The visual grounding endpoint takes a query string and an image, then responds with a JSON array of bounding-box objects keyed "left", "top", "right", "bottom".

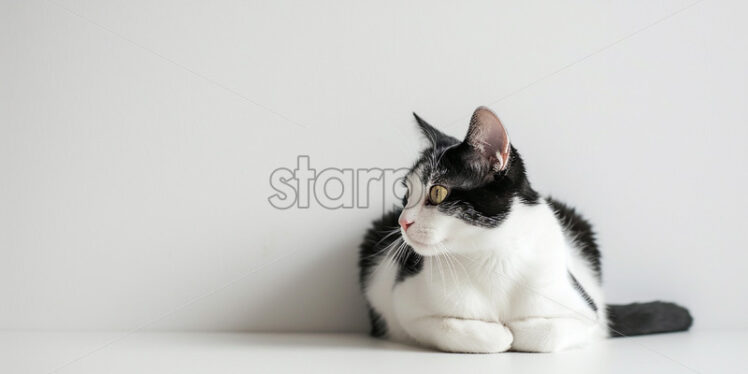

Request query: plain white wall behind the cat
[{"left": 0, "top": 0, "right": 748, "bottom": 331}]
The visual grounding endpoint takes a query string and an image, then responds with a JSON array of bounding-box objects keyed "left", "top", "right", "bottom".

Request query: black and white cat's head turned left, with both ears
[{"left": 399, "top": 107, "right": 538, "bottom": 256}]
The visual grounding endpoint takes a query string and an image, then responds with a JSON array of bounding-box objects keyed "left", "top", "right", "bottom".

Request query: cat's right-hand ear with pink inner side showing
[{"left": 464, "top": 106, "right": 510, "bottom": 171}]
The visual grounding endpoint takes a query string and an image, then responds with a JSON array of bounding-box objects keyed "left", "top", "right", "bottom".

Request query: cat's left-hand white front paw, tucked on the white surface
[{"left": 434, "top": 318, "right": 513, "bottom": 353}]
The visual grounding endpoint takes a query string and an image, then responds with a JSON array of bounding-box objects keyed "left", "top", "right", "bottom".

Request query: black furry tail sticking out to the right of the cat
[{"left": 608, "top": 301, "right": 693, "bottom": 337}]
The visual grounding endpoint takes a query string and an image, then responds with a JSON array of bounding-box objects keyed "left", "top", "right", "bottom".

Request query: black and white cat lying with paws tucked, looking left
[{"left": 359, "top": 107, "right": 692, "bottom": 352}]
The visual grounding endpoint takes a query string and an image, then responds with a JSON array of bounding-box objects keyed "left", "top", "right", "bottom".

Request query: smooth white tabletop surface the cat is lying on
[{"left": 0, "top": 330, "right": 748, "bottom": 374}]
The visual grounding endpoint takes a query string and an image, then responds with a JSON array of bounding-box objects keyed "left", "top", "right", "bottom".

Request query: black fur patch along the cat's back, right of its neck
[{"left": 546, "top": 196, "right": 601, "bottom": 281}]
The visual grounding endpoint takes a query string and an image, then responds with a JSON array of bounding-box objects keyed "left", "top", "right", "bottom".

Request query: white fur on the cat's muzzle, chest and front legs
[{"left": 366, "top": 171, "right": 608, "bottom": 353}]
